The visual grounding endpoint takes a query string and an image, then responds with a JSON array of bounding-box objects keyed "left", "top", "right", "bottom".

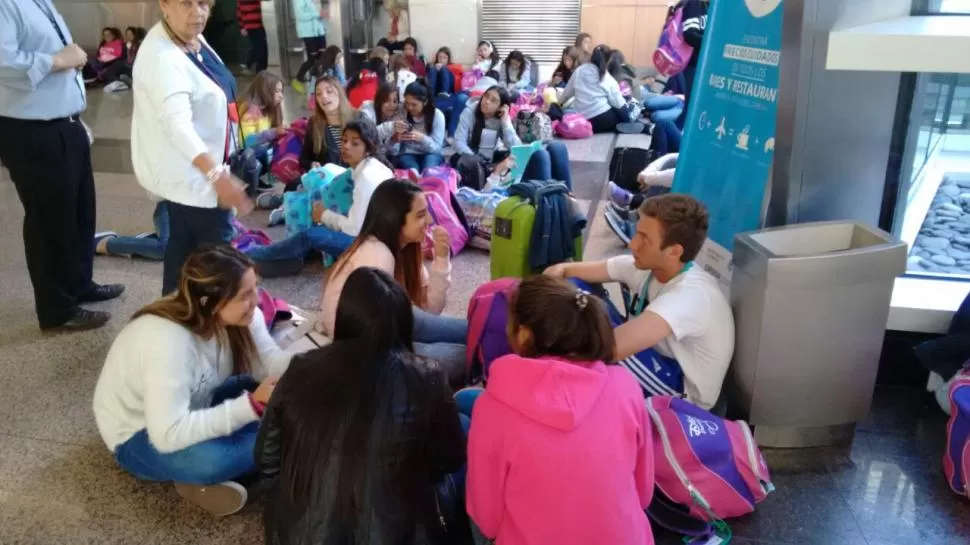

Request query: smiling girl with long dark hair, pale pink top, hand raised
[{"left": 320, "top": 180, "right": 468, "bottom": 385}]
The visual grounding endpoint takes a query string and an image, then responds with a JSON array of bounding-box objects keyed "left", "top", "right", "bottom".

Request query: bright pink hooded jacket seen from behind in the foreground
[{"left": 467, "top": 354, "right": 654, "bottom": 545}]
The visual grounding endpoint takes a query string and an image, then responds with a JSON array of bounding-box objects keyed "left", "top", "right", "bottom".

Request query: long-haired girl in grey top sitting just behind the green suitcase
[{"left": 451, "top": 85, "right": 573, "bottom": 189}]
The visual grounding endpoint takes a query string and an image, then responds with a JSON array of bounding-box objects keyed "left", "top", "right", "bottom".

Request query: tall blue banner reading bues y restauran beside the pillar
[{"left": 672, "top": 0, "right": 784, "bottom": 286}]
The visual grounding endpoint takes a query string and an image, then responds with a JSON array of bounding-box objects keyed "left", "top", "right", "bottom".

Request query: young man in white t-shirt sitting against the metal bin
[{"left": 545, "top": 194, "right": 734, "bottom": 409}]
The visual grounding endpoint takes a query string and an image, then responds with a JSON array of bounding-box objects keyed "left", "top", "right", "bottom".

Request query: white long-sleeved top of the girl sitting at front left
[{"left": 94, "top": 309, "right": 292, "bottom": 452}]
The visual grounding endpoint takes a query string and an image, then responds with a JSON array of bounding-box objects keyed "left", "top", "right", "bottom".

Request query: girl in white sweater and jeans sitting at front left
[{"left": 94, "top": 246, "right": 291, "bottom": 516}]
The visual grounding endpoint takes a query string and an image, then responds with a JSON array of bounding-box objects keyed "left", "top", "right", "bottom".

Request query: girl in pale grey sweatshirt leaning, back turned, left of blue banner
[{"left": 560, "top": 45, "right": 630, "bottom": 133}]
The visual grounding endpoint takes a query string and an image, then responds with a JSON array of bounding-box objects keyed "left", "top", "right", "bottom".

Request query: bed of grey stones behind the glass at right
[{"left": 908, "top": 173, "right": 970, "bottom": 275}]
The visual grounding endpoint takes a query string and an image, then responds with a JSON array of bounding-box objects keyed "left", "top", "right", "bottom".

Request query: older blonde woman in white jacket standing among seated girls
[{"left": 131, "top": 0, "right": 252, "bottom": 294}]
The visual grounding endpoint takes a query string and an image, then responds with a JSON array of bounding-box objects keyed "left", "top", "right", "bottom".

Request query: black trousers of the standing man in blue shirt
[{"left": 0, "top": 117, "right": 97, "bottom": 327}]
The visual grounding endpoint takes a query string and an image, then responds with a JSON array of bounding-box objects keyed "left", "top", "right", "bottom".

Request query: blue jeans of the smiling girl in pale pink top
[{"left": 414, "top": 307, "right": 468, "bottom": 385}]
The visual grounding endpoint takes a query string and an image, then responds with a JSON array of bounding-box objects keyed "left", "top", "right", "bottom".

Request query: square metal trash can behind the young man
[{"left": 727, "top": 221, "right": 907, "bottom": 448}]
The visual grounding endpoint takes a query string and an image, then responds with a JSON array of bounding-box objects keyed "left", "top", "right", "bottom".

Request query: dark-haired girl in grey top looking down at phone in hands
[{"left": 384, "top": 82, "right": 446, "bottom": 172}]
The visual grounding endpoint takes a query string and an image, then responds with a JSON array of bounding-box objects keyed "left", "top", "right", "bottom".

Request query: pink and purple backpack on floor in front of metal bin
[{"left": 647, "top": 396, "right": 775, "bottom": 522}]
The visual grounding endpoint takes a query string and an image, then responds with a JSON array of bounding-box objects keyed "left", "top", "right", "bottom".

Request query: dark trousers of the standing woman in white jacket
[{"left": 162, "top": 201, "right": 232, "bottom": 295}]
